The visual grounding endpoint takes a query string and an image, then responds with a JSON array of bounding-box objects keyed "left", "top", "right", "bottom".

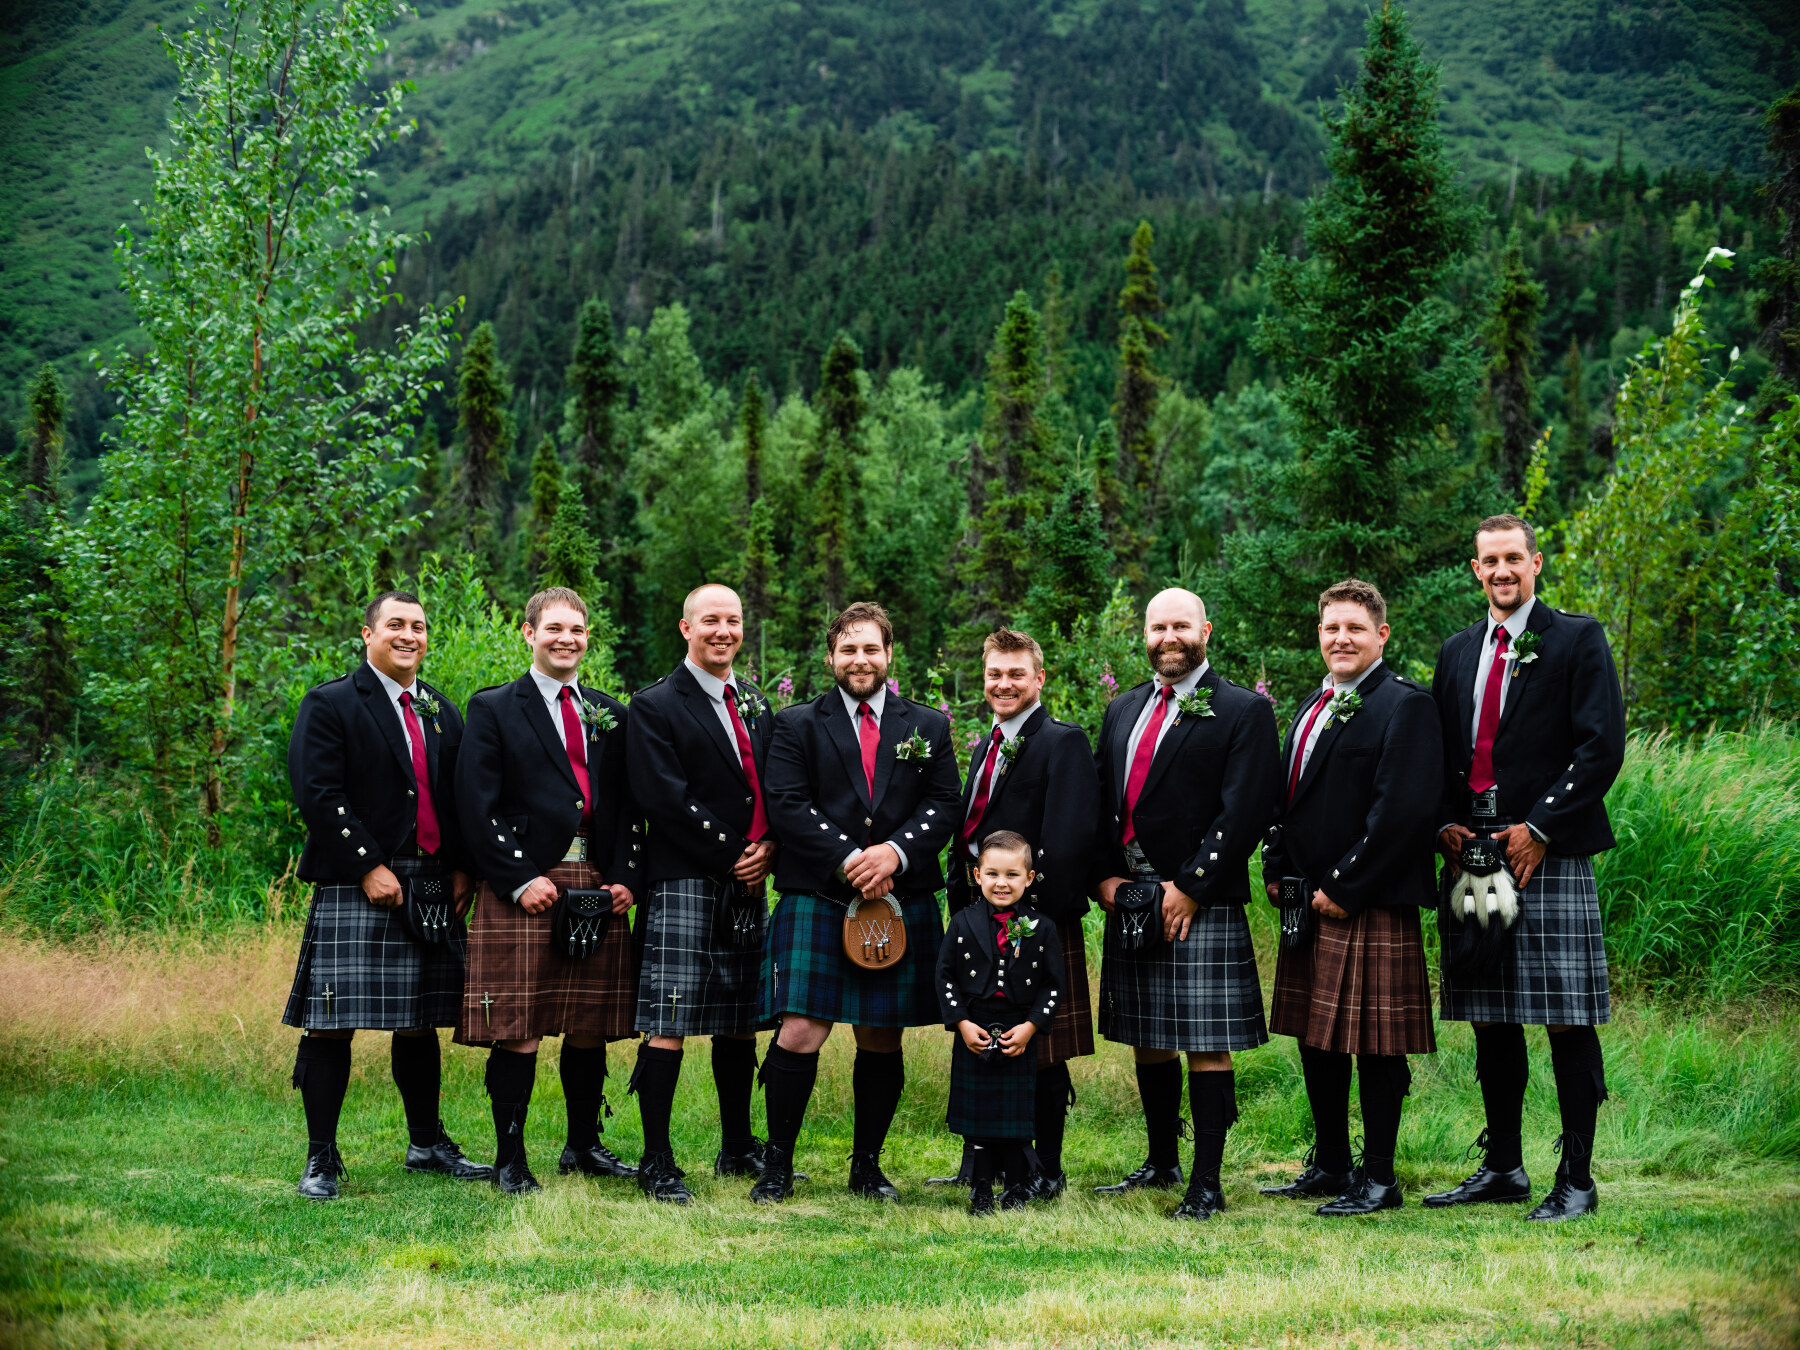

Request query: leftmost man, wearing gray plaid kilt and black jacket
[{"left": 281, "top": 590, "right": 490, "bottom": 1201}]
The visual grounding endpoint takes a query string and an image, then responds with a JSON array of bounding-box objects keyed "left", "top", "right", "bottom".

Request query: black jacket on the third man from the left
[{"left": 625, "top": 662, "right": 777, "bottom": 882}]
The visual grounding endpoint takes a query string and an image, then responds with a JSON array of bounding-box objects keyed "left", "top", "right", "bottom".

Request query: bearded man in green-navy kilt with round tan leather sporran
[{"left": 751, "top": 601, "right": 958, "bottom": 1202}]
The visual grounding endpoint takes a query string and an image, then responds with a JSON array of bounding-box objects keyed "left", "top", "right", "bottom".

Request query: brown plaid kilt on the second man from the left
[{"left": 455, "top": 862, "right": 637, "bottom": 1046}]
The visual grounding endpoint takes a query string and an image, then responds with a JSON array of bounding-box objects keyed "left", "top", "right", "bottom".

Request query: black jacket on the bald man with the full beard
[{"left": 1089, "top": 668, "right": 1282, "bottom": 907}]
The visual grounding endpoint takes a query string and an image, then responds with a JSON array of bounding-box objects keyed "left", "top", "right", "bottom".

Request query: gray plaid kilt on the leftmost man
[{"left": 281, "top": 857, "right": 468, "bottom": 1031}]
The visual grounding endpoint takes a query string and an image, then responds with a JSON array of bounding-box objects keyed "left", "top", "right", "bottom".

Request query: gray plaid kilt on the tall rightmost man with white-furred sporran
[{"left": 1438, "top": 853, "right": 1613, "bottom": 1026}]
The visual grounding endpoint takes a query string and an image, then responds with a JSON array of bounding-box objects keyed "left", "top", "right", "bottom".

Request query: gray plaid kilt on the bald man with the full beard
[{"left": 1100, "top": 905, "right": 1269, "bottom": 1053}]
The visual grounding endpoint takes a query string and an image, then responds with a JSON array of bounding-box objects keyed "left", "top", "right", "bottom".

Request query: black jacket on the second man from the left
[{"left": 455, "top": 671, "right": 644, "bottom": 898}]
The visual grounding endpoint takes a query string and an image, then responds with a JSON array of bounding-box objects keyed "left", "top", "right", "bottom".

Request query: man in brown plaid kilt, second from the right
[{"left": 1262, "top": 580, "right": 1444, "bottom": 1217}]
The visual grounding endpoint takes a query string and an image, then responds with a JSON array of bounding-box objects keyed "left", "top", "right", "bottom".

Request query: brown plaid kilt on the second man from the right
[{"left": 1269, "top": 905, "right": 1438, "bottom": 1055}]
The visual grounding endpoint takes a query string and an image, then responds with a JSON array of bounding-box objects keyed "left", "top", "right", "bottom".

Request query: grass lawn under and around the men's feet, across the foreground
[{"left": 0, "top": 925, "right": 1800, "bottom": 1346}]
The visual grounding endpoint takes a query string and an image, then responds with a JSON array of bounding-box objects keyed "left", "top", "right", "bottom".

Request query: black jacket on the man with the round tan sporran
[{"left": 763, "top": 686, "right": 961, "bottom": 904}]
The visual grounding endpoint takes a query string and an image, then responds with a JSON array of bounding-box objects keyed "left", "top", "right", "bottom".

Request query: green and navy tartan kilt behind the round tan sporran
[{"left": 756, "top": 891, "right": 943, "bottom": 1026}]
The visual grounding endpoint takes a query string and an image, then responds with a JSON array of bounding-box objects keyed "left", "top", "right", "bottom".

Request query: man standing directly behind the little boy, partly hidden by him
[{"left": 932, "top": 628, "right": 1100, "bottom": 1199}]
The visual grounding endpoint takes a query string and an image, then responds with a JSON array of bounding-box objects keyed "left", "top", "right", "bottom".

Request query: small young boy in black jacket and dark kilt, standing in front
[{"left": 936, "top": 830, "right": 1066, "bottom": 1215}]
